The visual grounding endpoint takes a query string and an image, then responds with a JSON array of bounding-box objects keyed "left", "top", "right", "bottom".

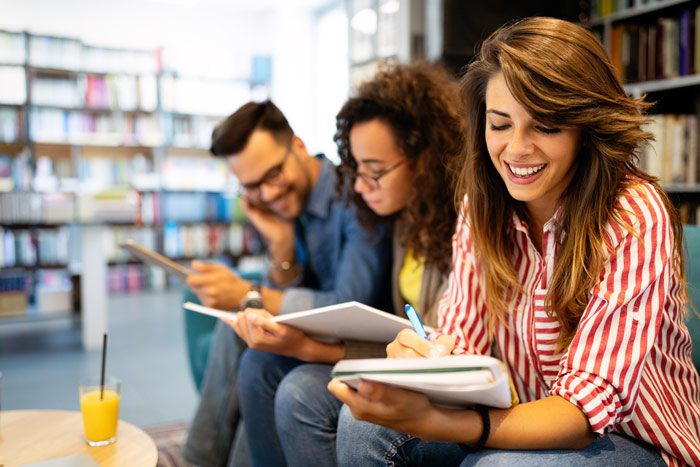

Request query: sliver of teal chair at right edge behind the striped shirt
[{"left": 683, "top": 225, "right": 700, "bottom": 371}]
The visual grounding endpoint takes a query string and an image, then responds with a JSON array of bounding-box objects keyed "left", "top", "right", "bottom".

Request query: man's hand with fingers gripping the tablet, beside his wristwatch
[{"left": 187, "top": 261, "right": 251, "bottom": 310}]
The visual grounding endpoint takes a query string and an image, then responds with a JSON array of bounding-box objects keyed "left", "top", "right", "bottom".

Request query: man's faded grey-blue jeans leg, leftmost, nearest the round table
[{"left": 182, "top": 322, "right": 248, "bottom": 467}]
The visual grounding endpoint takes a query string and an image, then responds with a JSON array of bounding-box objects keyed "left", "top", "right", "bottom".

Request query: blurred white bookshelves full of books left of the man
[{"left": 0, "top": 31, "right": 269, "bottom": 348}]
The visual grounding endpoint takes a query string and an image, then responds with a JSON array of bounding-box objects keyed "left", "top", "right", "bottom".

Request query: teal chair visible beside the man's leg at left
[{"left": 182, "top": 272, "right": 262, "bottom": 392}]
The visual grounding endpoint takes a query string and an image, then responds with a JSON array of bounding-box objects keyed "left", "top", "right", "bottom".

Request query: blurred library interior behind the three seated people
[{"left": 0, "top": 0, "right": 700, "bottom": 460}]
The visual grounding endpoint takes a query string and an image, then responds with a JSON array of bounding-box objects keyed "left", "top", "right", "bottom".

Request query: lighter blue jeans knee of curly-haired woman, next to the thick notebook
[{"left": 275, "top": 363, "right": 342, "bottom": 467}]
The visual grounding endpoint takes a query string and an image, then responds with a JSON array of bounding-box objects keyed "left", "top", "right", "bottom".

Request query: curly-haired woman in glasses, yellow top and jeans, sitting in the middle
[{"left": 232, "top": 63, "right": 464, "bottom": 466}]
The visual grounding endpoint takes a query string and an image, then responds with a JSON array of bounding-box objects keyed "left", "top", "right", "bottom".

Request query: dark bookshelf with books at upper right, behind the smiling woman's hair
[{"left": 588, "top": 0, "right": 700, "bottom": 224}]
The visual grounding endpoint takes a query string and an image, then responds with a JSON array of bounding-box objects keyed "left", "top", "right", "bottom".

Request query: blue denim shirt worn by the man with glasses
[{"left": 280, "top": 156, "right": 391, "bottom": 313}]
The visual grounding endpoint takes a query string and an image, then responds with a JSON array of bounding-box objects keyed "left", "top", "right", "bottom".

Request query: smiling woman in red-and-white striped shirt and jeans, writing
[{"left": 329, "top": 18, "right": 700, "bottom": 466}]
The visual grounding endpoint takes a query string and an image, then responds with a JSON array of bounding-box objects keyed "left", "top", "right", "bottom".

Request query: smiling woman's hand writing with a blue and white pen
[{"left": 386, "top": 305, "right": 455, "bottom": 358}]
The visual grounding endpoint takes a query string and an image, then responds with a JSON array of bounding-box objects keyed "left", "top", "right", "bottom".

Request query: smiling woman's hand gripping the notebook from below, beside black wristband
[{"left": 328, "top": 379, "right": 438, "bottom": 440}]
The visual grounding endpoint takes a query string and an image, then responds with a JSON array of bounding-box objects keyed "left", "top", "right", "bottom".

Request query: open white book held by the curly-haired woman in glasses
[{"left": 183, "top": 302, "right": 432, "bottom": 343}]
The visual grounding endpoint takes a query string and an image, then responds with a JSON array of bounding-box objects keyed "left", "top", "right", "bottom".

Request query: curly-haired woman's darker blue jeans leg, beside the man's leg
[{"left": 238, "top": 349, "right": 304, "bottom": 467}]
